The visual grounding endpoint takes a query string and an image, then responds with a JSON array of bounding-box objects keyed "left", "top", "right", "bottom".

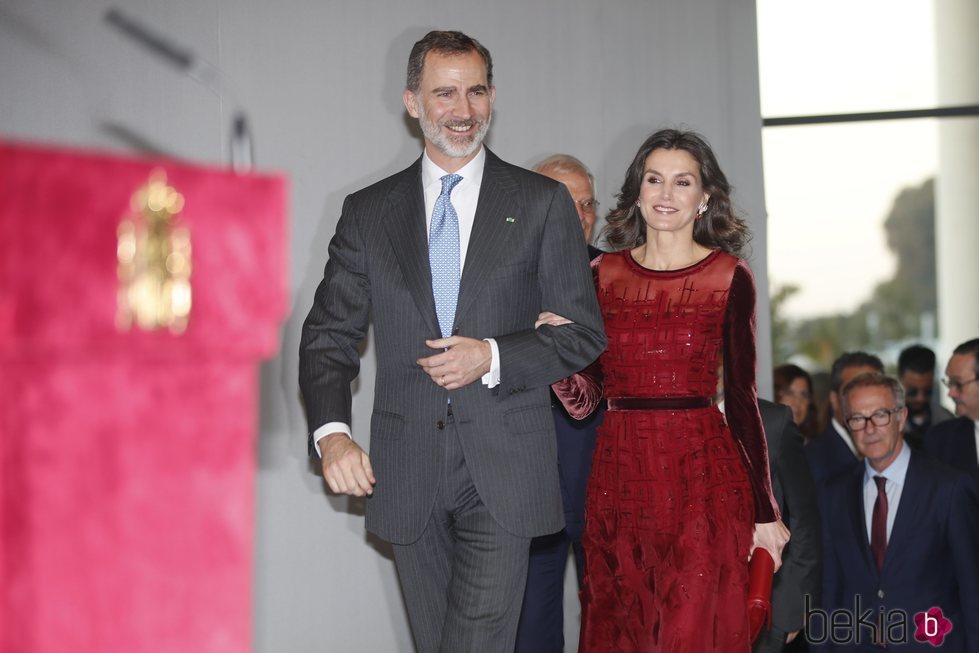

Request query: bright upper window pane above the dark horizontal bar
[{"left": 757, "top": 0, "right": 936, "bottom": 118}]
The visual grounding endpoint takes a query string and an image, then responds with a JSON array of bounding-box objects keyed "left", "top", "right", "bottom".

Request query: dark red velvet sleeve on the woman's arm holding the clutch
[{"left": 724, "top": 260, "right": 780, "bottom": 523}]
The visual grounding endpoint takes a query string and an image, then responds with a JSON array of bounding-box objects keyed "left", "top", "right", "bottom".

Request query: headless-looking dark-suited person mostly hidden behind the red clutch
[{"left": 752, "top": 399, "right": 822, "bottom": 653}]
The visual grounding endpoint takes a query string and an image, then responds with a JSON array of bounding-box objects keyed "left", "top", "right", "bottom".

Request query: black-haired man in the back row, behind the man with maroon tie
[{"left": 897, "top": 345, "right": 952, "bottom": 449}]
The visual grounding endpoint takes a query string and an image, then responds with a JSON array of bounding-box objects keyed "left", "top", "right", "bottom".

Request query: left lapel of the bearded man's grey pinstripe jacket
[{"left": 384, "top": 159, "right": 440, "bottom": 338}]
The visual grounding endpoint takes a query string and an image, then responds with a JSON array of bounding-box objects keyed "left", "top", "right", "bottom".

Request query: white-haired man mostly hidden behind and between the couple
[{"left": 514, "top": 154, "right": 605, "bottom": 653}]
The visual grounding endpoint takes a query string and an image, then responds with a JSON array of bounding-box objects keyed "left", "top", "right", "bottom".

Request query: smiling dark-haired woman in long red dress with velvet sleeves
[{"left": 538, "top": 130, "right": 789, "bottom": 653}]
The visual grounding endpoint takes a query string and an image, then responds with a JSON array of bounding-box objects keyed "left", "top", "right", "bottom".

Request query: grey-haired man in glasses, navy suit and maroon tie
[{"left": 810, "top": 373, "right": 979, "bottom": 653}]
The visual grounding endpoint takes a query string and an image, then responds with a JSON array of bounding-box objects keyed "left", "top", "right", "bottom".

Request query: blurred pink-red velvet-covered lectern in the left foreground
[{"left": 0, "top": 142, "right": 287, "bottom": 653}]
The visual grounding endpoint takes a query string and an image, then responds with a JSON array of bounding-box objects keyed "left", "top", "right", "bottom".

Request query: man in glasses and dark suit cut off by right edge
[{"left": 925, "top": 338, "right": 979, "bottom": 487}]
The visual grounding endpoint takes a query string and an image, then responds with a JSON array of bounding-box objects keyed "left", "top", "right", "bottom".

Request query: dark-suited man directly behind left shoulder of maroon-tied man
[{"left": 806, "top": 351, "right": 884, "bottom": 490}]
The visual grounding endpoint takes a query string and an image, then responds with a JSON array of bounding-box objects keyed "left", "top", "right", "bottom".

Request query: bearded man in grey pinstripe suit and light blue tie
[{"left": 299, "top": 32, "right": 605, "bottom": 653}]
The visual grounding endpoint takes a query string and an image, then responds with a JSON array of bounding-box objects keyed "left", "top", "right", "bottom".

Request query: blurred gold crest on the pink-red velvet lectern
[{"left": 116, "top": 168, "right": 191, "bottom": 334}]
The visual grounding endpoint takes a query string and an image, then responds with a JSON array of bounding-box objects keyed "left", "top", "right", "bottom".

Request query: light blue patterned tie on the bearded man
[{"left": 428, "top": 175, "right": 462, "bottom": 338}]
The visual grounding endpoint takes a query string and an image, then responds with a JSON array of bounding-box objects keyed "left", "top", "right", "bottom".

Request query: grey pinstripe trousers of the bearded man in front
[{"left": 394, "top": 417, "right": 531, "bottom": 653}]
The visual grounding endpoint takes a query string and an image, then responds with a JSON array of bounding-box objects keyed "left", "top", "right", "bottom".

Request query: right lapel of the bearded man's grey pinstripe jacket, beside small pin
[{"left": 456, "top": 149, "right": 522, "bottom": 323}]
